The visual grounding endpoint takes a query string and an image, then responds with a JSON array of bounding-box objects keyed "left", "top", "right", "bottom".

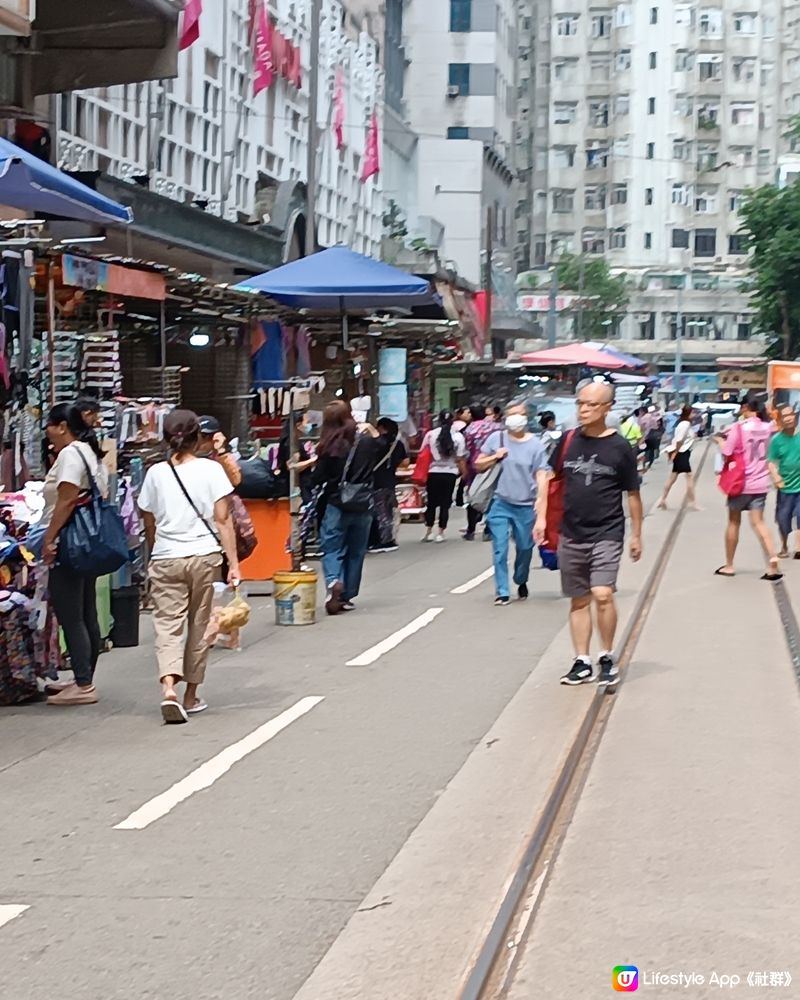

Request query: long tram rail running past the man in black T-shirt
[{"left": 459, "top": 445, "right": 712, "bottom": 1000}]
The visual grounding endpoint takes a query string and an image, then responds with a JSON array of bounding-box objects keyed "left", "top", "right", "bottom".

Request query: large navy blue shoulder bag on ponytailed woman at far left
[{"left": 58, "top": 448, "right": 128, "bottom": 576}]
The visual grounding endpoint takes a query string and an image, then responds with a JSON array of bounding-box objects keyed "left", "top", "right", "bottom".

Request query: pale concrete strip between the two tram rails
[{"left": 509, "top": 475, "right": 800, "bottom": 1000}]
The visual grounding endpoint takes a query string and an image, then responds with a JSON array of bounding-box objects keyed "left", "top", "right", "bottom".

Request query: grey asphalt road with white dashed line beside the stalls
[{"left": 0, "top": 526, "right": 576, "bottom": 1000}]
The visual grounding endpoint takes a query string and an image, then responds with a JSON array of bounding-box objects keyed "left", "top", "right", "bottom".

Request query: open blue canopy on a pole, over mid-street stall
[{"left": 235, "top": 246, "right": 433, "bottom": 313}]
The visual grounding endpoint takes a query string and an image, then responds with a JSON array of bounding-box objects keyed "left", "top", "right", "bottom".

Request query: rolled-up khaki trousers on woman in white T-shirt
[{"left": 148, "top": 552, "right": 222, "bottom": 684}]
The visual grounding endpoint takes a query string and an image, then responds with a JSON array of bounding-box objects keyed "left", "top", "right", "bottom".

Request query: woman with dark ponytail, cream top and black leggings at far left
[{"left": 41, "top": 403, "right": 108, "bottom": 705}]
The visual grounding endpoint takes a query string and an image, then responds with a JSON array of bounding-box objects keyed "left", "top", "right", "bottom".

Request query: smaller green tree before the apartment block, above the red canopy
[{"left": 556, "top": 254, "right": 628, "bottom": 340}]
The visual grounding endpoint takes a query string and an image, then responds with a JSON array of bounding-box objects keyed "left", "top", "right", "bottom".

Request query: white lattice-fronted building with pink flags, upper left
[{"left": 56, "top": 0, "right": 384, "bottom": 254}]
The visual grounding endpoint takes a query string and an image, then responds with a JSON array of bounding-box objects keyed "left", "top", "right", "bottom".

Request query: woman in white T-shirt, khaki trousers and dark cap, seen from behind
[{"left": 139, "top": 410, "right": 239, "bottom": 723}]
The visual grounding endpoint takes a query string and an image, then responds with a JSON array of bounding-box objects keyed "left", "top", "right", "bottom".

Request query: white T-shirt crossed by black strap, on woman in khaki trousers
[{"left": 139, "top": 458, "right": 233, "bottom": 559}]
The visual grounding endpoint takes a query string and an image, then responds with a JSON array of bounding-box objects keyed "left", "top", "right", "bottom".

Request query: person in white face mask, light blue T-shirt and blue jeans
[{"left": 475, "top": 403, "right": 550, "bottom": 607}]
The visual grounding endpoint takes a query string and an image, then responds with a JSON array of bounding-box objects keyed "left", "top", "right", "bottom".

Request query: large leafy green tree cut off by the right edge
[{"left": 740, "top": 183, "right": 800, "bottom": 358}]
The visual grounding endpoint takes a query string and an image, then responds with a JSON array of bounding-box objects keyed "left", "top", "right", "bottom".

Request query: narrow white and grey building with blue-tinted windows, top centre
[{"left": 403, "top": 0, "right": 517, "bottom": 284}]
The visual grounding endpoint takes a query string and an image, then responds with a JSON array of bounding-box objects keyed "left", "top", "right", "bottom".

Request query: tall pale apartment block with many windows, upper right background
[{"left": 517, "top": 0, "right": 800, "bottom": 360}]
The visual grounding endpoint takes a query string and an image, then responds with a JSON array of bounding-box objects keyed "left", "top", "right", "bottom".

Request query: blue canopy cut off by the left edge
[{"left": 0, "top": 138, "right": 132, "bottom": 224}]
